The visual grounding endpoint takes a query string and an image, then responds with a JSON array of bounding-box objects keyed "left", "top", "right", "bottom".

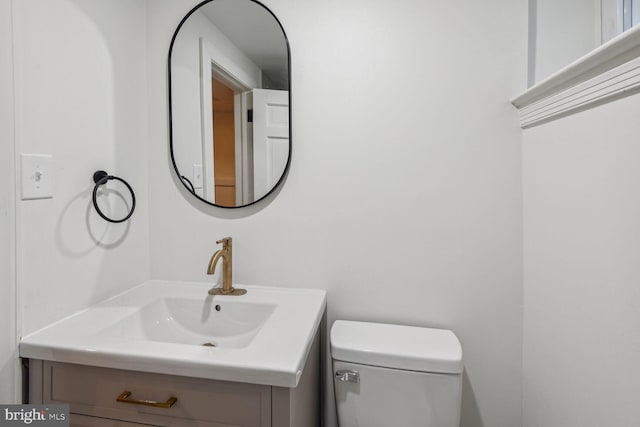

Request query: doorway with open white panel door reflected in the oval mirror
[{"left": 208, "top": 64, "right": 290, "bottom": 207}]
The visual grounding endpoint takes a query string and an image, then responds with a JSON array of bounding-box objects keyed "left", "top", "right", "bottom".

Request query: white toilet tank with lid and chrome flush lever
[{"left": 331, "top": 320, "right": 463, "bottom": 427}]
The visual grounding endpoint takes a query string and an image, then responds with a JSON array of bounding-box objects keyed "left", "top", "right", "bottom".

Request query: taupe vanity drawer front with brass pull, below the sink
[{"left": 43, "top": 362, "right": 271, "bottom": 427}]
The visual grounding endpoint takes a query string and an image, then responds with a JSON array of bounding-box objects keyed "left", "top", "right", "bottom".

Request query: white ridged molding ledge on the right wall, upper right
[{"left": 511, "top": 26, "right": 640, "bottom": 128}]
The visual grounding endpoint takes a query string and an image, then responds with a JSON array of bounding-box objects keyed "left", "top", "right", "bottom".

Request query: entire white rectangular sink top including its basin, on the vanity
[{"left": 20, "top": 281, "right": 326, "bottom": 387}]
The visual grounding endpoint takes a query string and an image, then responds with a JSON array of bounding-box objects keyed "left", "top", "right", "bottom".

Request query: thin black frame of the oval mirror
[{"left": 167, "top": 0, "right": 293, "bottom": 209}]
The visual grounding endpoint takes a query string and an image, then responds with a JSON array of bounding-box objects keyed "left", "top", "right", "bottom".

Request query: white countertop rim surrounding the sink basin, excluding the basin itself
[{"left": 20, "top": 280, "right": 326, "bottom": 387}]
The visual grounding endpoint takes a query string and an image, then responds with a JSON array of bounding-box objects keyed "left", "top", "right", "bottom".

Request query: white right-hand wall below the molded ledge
[{"left": 523, "top": 95, "right": 640, "bottom": 427}]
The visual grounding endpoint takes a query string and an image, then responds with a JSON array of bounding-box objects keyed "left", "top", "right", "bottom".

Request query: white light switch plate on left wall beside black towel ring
[{"left": 21, "top": 154, "right": 55, "bottom": 200}]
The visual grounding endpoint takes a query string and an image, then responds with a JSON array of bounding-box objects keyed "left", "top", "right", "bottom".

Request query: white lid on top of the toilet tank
[{"left": 331, "top": 320, "right": 463, "bottom": 374}]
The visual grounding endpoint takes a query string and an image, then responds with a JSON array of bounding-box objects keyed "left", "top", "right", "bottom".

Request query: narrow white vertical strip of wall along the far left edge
[{"left": 0, "top": 0, "right": 19, "bottom": 403}]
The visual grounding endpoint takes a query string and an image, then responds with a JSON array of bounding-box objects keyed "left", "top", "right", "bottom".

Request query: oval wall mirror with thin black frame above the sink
[{"left": 169, "top": 0, "right": 291, "bottom": 208}]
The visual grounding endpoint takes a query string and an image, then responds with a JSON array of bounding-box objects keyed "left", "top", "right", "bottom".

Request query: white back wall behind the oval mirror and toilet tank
[{"left": 147, "top": 0, "right": 527, "bottom": 427}]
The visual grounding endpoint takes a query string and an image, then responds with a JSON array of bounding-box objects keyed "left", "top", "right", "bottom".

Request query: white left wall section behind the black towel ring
[{"left": 13, "top": 0, "right": 149, "bottom": 334}]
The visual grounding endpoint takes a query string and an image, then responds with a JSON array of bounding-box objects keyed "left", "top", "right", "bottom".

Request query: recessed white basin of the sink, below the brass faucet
[{"left": 99, "top": 297, "right": 276, "bottom": 348}]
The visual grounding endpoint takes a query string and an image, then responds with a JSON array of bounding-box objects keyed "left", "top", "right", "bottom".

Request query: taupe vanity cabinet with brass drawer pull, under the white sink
[{"left": 29, "top": 335, "right": 320, "bottom": 427}]
